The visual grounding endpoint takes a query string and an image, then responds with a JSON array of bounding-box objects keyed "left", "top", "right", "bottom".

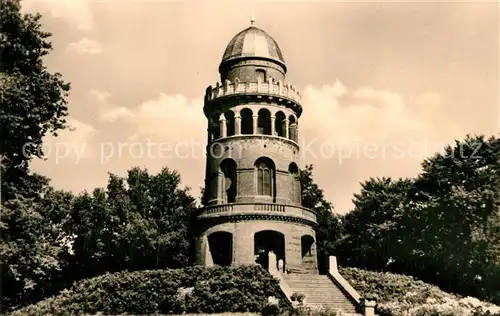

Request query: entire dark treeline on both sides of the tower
[{"left": 0, "top": 0, "right": 500, "bottom": 312}]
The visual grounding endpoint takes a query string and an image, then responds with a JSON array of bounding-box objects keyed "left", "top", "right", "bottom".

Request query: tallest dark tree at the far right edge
[{"left": 416, "top": 135, "right": 500, "bottom": 303}]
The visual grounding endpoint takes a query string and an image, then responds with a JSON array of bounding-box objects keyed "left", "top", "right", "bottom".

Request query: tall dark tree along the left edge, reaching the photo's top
[{"left": 0, "top": 0, "right": 71, "bottom": 307}]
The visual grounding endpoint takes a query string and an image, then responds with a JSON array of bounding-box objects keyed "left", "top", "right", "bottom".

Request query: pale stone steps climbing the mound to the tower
[{"left": 283, "top": 274, "right": 362, "bottom": 315}]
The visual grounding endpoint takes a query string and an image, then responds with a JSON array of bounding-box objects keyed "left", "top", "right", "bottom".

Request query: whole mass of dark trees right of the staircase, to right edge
[{"left": 339, "top": 136, "right": 500, "bottom": 303}]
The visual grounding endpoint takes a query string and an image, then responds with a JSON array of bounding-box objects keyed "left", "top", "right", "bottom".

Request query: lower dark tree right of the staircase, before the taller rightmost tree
[{"left": 339, "top": 178, "right": 413, "bottom": 270}]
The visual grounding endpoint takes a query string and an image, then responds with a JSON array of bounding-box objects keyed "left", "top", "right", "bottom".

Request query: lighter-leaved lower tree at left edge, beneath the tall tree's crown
[{"left": 0, "top": 190, "right": 73, "bottom": 309}]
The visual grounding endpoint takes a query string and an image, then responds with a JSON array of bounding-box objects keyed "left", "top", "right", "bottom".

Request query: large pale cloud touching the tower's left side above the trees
[{"left": 85, "top": 90, "right": 207, "bottom": 196}]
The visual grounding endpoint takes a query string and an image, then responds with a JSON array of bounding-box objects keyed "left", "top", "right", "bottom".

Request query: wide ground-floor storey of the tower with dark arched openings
[{"left": 196, "top": 220, "right": 317, "bottom": 273}]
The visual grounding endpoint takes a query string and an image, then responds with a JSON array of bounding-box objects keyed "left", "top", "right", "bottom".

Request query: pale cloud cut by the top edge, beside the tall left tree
[{"left": 21, "top": 0, "right": 94, "bottom": 31}]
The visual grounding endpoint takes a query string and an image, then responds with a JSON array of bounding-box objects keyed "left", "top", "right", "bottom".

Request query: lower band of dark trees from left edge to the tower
[{"left": 0, "top": 168, "right": 195, "bottom": 308}]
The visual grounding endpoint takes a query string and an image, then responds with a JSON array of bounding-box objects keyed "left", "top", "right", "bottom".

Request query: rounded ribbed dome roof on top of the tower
[{"left": 221, "top": 26, "right": 285, "bottom": 65}]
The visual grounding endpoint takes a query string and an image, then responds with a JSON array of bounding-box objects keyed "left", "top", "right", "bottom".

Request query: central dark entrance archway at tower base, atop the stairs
[{"left": 254, "top": 230, "right": 286, "bottom": 270}]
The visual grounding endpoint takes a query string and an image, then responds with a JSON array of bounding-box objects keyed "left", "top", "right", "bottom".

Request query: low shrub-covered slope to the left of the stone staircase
[{"left": 11, "top": 265, "right": 281, "bottom": 316}]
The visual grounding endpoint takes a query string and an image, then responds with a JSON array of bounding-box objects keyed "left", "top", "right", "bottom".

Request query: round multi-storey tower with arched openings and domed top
[{"left": 196, "top": 20, "right": 317, "bottom": 273}]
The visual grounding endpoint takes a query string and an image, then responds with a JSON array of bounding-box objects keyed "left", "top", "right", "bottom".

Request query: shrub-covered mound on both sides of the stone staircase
[{"left": 11, "top": 266, "right": 500, "bottom": 316}]
